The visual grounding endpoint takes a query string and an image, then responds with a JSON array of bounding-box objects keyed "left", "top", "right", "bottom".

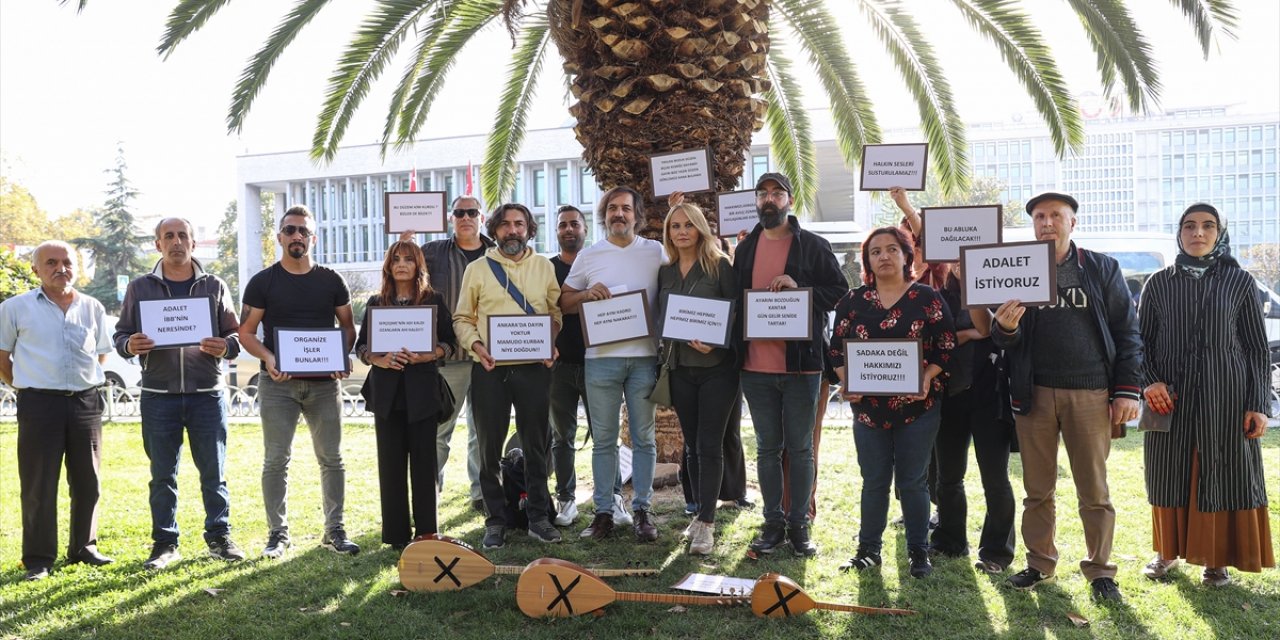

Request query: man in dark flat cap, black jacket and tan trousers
[{"left": 992, "top": 192, "right": 1142, "bottom": 602}]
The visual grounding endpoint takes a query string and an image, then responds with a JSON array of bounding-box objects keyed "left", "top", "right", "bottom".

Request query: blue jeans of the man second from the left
[{"left": 141, "top": 392, "right": 230, "bottom": 545}]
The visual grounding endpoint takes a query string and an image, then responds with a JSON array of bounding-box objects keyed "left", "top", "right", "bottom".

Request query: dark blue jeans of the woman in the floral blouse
[{"left": 854, "top": 404, "right": 942, "bottom": 553}]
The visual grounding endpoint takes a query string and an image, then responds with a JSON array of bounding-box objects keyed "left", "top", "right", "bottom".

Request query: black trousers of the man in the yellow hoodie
[{"left": 471, "top": 362, "right": 552, "bottom": 526}]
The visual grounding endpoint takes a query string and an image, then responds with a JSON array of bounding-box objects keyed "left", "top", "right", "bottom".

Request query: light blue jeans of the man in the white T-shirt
[{"left": 584, "top": 357, "right": 655, "bottom": 513}]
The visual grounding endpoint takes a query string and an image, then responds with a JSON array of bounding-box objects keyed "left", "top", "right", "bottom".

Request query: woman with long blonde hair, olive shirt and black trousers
[{"left": 657, "top": 198, "right": 739, "bottom": 556}]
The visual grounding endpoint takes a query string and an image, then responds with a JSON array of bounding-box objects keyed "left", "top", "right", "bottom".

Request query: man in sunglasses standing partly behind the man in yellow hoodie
[{"left": 401, "top": 193, "right": 495, "bottom": 513}]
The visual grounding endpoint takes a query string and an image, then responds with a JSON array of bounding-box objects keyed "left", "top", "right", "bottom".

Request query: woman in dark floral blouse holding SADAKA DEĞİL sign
[{"left": 831, "top": 227, "right": 956, "bottom": 577}]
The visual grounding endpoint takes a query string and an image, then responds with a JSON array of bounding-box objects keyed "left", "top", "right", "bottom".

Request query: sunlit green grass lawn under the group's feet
[{"left": 0, "top": 419, "right": 1280, "bottom": 639}]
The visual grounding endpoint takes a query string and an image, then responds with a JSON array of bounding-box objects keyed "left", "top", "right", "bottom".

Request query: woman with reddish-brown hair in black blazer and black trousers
[{"left": 356, "top": 241, "right": 457, "bottom": 549}]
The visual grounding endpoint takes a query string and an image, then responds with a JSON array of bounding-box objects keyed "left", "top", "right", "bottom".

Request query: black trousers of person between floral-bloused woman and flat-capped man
[{"left": 929, "top": 389, "right": 1015, "bottom": 567}]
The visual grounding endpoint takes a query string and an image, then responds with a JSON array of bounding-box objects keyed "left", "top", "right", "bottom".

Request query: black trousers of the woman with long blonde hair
[{"left": 671, "top": 358, "right": 740, "bottom": 522}]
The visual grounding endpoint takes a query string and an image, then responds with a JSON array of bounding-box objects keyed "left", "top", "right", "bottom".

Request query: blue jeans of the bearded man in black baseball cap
[{"left": 742, "top": 371, "right": 822, "bottom": 525}]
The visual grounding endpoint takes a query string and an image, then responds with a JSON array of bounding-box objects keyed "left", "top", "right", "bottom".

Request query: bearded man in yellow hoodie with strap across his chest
[{"left": 453, "top": 204, "right": 561, "bottom": 549}]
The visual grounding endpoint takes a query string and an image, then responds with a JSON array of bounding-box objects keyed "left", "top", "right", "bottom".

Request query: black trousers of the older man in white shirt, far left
[{"left": 18, "top": 389, "right": 102, "bottom": 570}]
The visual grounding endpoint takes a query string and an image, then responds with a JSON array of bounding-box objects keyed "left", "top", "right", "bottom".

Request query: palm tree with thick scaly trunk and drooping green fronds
[{"left": 127, "top": 0, "right": 1236, "bottom": 230}]
